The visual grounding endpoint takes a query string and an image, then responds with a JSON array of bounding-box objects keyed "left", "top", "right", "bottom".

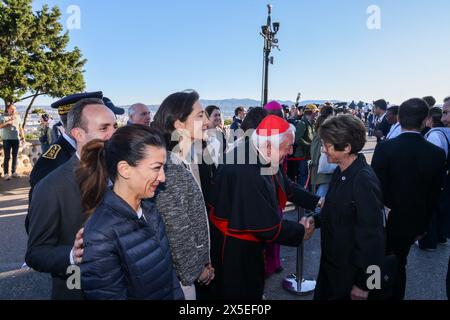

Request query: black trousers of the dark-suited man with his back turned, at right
[{"left": 386, "top": 229, "right": 415, "bottom": 300}]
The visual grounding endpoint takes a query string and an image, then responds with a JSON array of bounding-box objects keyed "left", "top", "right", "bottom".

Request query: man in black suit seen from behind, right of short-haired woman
[{"left": 372, "top": 99, "right": 445, "bottom": 300}]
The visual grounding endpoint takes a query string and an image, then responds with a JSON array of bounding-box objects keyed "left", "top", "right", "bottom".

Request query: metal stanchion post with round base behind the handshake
[{"left": 283, "top": 208, "right": 316, "bottom": 296}]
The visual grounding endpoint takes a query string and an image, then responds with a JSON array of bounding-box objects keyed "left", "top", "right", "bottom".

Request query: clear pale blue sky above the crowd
[{"left": 34, "top": 0, "right": 450, "bottom": 105}]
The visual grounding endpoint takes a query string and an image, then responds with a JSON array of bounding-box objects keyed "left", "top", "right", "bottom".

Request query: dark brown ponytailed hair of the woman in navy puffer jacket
[{"left": 76, "top": 125, "right": 166, "bottom": 220}]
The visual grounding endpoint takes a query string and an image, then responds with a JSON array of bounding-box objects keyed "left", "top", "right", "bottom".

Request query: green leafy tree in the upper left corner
[{"left": 0, "top": 0, "right": 86, "bottom": 126}]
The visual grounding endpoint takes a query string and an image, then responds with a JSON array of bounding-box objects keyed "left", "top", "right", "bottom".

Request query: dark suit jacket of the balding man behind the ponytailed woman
[{"left": 25, "top": 155, "right": 83, "bottom": 300}]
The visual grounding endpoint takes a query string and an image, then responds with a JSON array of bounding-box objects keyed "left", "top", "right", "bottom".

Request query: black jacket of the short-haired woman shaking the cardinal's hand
[{"left": 315, "top": 155, "right": 384, "bottom": 300}]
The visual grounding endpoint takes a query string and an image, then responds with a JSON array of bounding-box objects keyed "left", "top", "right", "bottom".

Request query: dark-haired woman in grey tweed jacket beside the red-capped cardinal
[{"left": 152, "top": 91, "right": 214, "bottom": 300}]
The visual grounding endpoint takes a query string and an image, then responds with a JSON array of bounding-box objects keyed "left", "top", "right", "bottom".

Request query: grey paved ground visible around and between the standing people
[{"left": 0, "top": 139, "right": 450, "bottom": 300}]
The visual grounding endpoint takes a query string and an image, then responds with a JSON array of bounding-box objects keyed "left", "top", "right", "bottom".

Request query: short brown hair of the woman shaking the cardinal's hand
[{"left": 319, "top": 114, "right": 366, "bottom": 154}]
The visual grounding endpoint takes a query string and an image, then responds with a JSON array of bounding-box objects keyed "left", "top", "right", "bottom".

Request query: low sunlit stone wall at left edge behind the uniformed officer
[{"left": 0, "top": 140, "right": 42, "bottom": 175}]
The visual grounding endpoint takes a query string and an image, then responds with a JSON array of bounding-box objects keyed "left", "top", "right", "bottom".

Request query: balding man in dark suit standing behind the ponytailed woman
[{"left": 25, "top": 99, "right": 117, "bottom": 300}]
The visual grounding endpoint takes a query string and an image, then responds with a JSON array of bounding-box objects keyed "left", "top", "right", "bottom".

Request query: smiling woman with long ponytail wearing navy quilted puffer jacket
[{"left": 76, "top": 126, "right": 184, "bottom": 300}]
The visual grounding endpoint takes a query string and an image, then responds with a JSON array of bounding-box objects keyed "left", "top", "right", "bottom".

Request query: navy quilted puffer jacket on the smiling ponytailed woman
[{"left": 81, "top": 190, "right": 184, "bottom": 300}]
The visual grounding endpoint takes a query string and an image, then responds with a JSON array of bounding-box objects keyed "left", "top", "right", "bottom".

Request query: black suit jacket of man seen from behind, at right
[{"left": 372, "top": 133, "right": 445, "bottom": 238}]
